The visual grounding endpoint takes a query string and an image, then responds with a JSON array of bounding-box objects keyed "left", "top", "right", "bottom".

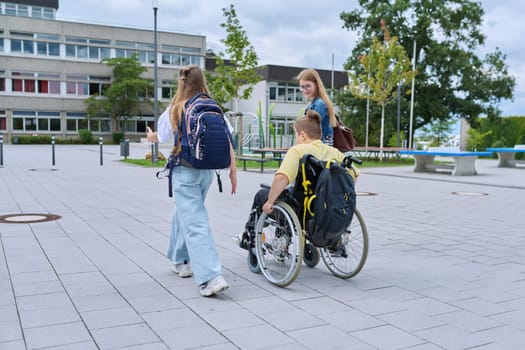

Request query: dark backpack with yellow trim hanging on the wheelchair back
[{"left": 294, "top": 154, "right": 356, "bottom": 247}]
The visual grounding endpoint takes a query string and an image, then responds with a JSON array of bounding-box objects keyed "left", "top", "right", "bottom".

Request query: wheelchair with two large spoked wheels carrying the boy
[{"left": 245, "top": 156, "right": 368, "bottom": 287}]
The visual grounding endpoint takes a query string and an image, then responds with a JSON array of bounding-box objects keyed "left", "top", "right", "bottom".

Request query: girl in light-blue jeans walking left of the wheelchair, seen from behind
[{"left": 147, "top": 65, "right": 237, "bottom": 296}]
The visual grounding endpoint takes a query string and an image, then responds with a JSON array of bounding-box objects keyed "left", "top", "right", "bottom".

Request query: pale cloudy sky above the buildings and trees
[{"left": 57, "top": 0, "right": 525, "bottom": 116}]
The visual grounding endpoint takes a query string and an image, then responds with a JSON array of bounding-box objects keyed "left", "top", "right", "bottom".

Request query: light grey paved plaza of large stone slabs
[{"left": 0, "top": 143, "right": 525, "bottom": 350}]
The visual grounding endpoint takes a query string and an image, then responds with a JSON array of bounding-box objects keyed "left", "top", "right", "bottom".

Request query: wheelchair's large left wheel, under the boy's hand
[{"left": 255, "top": 201, "right": 304, "bottom": 287}]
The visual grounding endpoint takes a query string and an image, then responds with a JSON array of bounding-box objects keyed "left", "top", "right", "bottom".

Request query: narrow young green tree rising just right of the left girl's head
[{"left": 208, "top": 5, "right": 261, "bottom": 111}]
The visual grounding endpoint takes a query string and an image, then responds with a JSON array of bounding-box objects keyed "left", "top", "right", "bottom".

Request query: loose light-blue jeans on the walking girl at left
[{"left": 166, "top": 166, "right": 222, "bottom": 285}]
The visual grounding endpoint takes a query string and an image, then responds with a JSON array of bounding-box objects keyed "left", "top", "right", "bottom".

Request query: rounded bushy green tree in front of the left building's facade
[{"left": 84, "top": 53, "right": 153, "bottom": 131}]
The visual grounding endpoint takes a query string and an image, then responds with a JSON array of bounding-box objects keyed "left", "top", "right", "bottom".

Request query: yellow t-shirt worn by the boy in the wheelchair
[{"left": 276, "top": 140, "right": 359, "bottom": 184}]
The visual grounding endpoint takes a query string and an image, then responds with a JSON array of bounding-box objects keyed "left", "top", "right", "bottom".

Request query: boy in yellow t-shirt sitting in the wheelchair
[{"left": 239, "top": 110, "right": 359, "bottom": 250}]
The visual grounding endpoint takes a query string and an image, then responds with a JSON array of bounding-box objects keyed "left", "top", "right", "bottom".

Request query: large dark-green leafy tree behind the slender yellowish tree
[{"left": 340, "top": 0, "right": 516, "bottom": 139}]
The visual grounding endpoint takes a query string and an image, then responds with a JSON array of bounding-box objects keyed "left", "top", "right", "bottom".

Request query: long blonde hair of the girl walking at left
[{"left": 170, "top": 64, "right": 210, "bottom": 153}]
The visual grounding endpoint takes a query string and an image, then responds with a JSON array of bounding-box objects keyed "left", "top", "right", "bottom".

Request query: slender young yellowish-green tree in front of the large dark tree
[{"left": 348, "top": 20, "right": 416, "bottom": 159}]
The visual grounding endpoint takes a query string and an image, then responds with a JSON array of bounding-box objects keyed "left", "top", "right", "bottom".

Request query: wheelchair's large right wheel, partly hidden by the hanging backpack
[{"left": 320, "top": 208, "right": 368, "bottom": 278}]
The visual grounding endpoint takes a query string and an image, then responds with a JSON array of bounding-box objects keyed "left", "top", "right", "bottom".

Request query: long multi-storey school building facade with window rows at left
[{"left": 0, "top": 1, "right": 206, "bottom": 141}]
